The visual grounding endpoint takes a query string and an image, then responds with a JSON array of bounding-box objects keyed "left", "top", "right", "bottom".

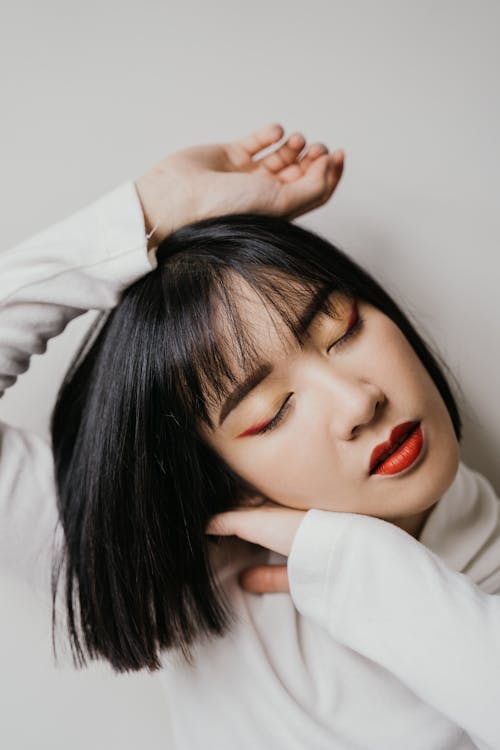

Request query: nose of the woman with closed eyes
[{"left": 322, "top": 375, "right": 386, "bottom": 440}]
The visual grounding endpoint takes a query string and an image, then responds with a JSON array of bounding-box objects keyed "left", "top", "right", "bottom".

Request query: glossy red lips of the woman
[{"left": 369, "top": 422, "right": 424, "bottom": 474}]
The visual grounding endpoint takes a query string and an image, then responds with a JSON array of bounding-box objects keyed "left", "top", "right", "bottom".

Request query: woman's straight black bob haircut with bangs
[{"left": 51, "top": 215, "right": 461, "bottom": 672}]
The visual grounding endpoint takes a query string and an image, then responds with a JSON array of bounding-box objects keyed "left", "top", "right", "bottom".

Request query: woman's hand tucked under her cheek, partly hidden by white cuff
[{"left": 206, "top": 500, "right": 307, "bottom": 593}]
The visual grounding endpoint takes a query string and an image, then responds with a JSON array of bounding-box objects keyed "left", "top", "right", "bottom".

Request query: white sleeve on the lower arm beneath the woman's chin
[{"left": 287, "top": 509, "right": 500, "bottom": 747}]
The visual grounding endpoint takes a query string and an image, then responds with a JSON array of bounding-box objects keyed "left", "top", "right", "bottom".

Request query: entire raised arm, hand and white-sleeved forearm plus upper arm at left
[{"left": 0, "top": 126, "right": 343, "bottom": 592}]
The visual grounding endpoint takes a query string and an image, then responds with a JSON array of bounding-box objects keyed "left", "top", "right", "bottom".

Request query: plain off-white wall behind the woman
[{"left": 0, "top": 0, "right": 500, "bottom": 750}]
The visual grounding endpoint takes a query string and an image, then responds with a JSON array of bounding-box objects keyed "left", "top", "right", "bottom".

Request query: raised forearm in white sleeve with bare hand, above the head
[{"left": 0, "top": 125, "right": 343, "bottom": 402}]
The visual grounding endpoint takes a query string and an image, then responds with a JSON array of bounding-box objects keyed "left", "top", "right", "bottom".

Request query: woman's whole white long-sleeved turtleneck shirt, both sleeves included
[{"left": 0, "top": 182, "right": 500, "bottom": 750}]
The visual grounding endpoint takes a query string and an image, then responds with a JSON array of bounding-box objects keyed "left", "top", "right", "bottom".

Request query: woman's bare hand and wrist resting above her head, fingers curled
[{"left": 135, "top": 125, "right": 344, "bottom": 248}]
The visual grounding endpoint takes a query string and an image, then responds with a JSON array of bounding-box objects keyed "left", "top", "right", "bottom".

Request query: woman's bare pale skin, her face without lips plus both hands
[{"left": 136, "top": 125, "right": 459, "bottom": 593}]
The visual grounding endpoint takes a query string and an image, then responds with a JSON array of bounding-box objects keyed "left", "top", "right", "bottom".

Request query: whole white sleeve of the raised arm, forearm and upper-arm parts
[{"left": 0, "top": 181, "right": 156, "bottom": 592}]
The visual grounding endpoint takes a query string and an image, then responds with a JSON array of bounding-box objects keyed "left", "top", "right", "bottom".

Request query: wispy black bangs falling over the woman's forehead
[{"left": 156, "top": 229, "right": 355, "bottom": 430}]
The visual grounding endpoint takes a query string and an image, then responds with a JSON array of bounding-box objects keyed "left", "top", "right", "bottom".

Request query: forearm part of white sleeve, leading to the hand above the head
[{"left": 0, "top": 181, "right": 152, "bottom": 394}]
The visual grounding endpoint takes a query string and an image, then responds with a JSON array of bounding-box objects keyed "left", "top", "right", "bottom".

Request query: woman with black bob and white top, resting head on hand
[{"left": 2, "top": 126, "right": 500, "bottom": 748}]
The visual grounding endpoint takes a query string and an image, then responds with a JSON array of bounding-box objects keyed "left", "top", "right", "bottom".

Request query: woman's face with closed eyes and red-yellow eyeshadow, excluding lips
[{"left": 203, "top": 282, "right": 460, "bottom": 533}]
